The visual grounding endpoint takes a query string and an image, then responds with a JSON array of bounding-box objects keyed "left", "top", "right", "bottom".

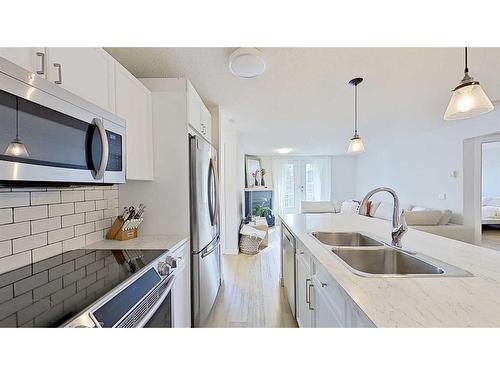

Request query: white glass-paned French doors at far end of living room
[{"left": 282, "top": 159, "right": 331, "bottom": 214}]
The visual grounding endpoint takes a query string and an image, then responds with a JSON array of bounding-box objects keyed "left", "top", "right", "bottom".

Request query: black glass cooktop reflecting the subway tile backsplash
[{"left": 0, "top": 250, "right": 166, "bottom": 327}]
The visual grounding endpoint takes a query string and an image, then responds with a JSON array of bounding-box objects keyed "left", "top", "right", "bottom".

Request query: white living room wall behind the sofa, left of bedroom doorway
[{"left": 356, "top": 111, "right": 500, "bottom": 223}]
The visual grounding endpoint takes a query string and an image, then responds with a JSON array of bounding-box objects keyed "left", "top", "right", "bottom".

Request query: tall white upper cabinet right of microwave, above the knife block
[{"left": 115, "top": 62, "right": 153, "bottom": 180}]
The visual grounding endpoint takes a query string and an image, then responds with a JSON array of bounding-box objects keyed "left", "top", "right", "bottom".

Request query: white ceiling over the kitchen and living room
[{"left": 106, "top": 48, "right": 500, "bottom": 155}]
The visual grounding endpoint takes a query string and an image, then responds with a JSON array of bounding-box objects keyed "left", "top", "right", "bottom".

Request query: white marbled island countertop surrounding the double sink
[{"left": 281, "top": 213, "right": 500, "bottom": 327}]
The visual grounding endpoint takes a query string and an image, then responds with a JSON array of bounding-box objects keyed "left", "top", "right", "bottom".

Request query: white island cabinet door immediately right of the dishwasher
[{"left": 295, "top": 244, "right": 314, "bottom": 328}]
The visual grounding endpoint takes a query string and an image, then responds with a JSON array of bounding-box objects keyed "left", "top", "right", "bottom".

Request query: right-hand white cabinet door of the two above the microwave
[{"left": 47, "top": 48, "right": 115, "bottom": 112}]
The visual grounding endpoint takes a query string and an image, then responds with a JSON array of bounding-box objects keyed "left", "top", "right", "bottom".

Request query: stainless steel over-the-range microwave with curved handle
[{"left": 0, "top": 58, "right": 126, "bottom": 186}]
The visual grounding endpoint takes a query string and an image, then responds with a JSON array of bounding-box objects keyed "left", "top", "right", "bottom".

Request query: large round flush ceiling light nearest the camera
[{"left": 229, "top": 48, "right": 266, "bottom": 78}]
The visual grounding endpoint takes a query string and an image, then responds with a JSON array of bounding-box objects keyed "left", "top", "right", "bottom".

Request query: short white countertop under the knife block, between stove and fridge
[{"left": 84, "top": 234, "right": 189, "bottom": 250}]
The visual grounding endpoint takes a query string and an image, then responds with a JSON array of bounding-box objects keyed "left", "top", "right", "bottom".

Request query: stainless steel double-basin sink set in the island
[{"left": 311, "top": 232, "right": 472, "bottom": 277}]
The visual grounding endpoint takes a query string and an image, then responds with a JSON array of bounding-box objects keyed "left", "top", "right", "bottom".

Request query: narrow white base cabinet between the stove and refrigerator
[{"left": 172, "top": 244, "right": 191, "bottom": 328}]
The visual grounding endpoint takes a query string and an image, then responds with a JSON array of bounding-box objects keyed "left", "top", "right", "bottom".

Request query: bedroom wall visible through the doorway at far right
[{"left": 482, "top": 142, "right": 500, "bottom": 197}]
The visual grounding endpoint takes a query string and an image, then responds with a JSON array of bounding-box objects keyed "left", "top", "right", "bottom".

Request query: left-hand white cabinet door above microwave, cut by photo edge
[{"left": 0, "top": 47, "right": 47, "bottom": 78}]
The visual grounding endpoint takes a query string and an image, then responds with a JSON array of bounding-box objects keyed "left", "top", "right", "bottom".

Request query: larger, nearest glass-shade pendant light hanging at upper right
[{"left": 444, "top": 47, "right": 494, "bottom": 120}]
